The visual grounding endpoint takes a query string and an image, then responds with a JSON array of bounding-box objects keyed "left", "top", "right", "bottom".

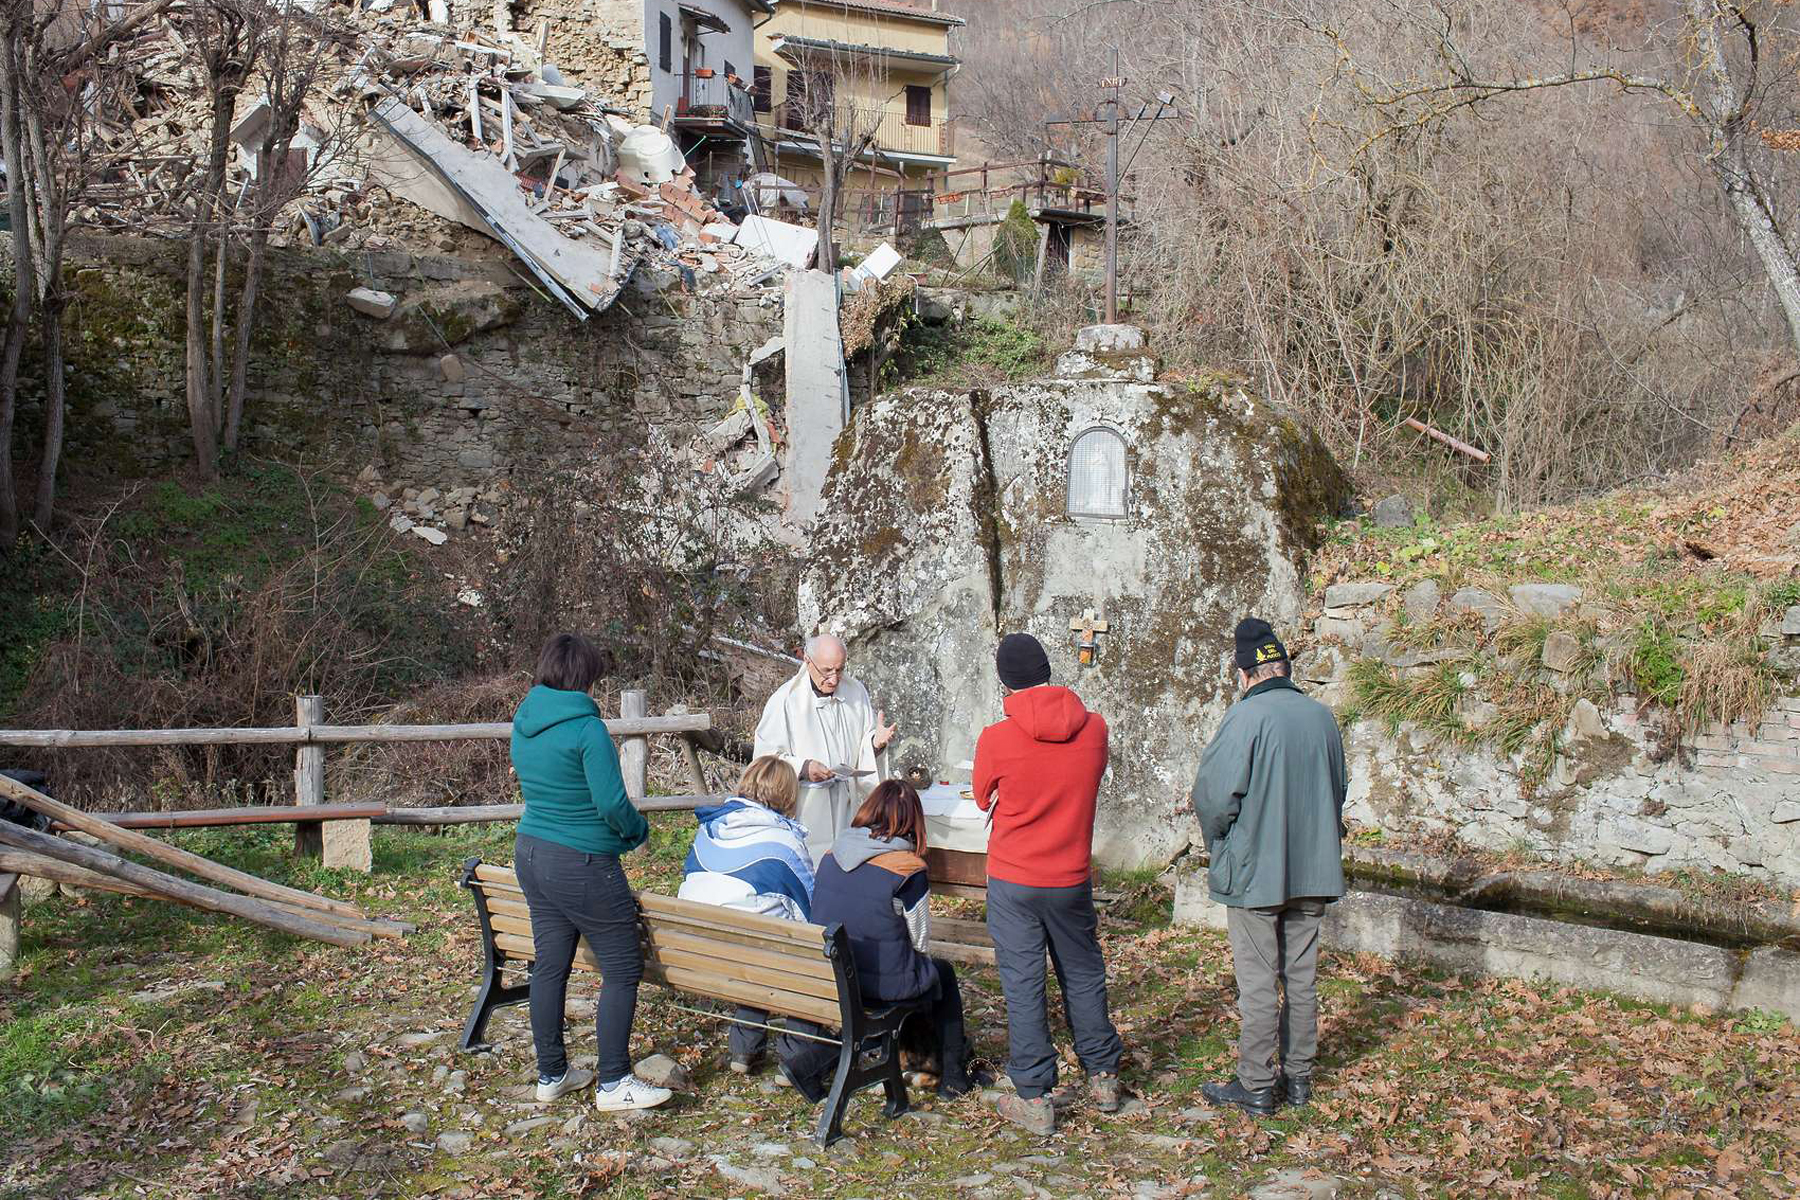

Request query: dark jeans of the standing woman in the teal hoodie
[{"left": 513, "top": 833, "right": 644, "bottom": 1083}]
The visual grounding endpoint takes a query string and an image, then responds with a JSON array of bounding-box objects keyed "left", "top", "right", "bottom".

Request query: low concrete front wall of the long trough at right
[{"left": 1174, "top": 862, "right": 1800, "bottom": 1020}]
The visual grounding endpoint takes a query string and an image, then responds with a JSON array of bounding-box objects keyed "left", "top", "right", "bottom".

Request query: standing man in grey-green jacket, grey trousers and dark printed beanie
[{"left": 1192, "top": 617, "right": 1348, "bottom": 1115}]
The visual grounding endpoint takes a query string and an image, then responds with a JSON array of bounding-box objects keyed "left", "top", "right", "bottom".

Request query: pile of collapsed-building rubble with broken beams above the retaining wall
[{"left": 77, "top": 4, "right": 814, "bottom": 317}]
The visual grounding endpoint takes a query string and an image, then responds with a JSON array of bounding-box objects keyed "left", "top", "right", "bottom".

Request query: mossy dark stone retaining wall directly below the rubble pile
[{"left": 7, "top": 239, "right": 781, "bottom": 521}]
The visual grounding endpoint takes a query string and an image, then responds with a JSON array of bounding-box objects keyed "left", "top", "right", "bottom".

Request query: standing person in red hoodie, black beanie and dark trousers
[{"left": 972, "top": 633, "right": 1125, "bottom": 1135}]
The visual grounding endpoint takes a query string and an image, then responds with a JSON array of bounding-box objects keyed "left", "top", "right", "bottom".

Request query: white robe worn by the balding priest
[{"left": 756, "top": 666, "right": 887, "bottom": 864}]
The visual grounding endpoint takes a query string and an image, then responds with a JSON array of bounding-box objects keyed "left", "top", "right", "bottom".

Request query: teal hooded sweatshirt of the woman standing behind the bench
[{"left": 513, "top": 684, "right": 650, "bottom": 855}]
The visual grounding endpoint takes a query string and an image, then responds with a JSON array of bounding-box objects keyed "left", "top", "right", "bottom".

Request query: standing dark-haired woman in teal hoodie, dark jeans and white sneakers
[{"left": 513, "top": 633, "right": 670, "bottom": 1112}]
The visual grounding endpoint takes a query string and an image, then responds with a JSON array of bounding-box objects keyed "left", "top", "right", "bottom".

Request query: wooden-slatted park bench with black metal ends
[{"left": 463, "top": 858, "right": 923, "bottom": 1146}]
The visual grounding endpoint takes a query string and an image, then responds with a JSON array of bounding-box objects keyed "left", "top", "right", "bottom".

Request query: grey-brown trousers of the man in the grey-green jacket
[{"left": 1226, "top": 900, "right": 1325, "bottom": 1092}]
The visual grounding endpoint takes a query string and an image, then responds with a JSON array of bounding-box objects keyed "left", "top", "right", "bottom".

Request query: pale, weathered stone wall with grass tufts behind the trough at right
[{"left": 1296, "top": 583, "right": 1800, "bottom": 887}]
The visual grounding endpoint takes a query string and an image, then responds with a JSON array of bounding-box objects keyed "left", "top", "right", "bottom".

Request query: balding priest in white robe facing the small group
[{"left": 756, "top": 633, "right": 895, "bottom": 864}]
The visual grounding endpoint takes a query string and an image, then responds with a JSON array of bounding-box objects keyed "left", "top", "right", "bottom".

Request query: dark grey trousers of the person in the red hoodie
[{"left": 988, "top": 878, "right": 1125, "bottom": 1099}]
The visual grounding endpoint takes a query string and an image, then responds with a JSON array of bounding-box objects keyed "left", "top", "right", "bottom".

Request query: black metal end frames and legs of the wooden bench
[{"left": 461, "top": 858, "right": 925, "bottom": 1146}]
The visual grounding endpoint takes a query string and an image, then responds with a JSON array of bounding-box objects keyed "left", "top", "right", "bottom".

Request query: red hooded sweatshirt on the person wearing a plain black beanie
[{"left": 974, "top": 684, "right": 1107, "bottom": 887}]
